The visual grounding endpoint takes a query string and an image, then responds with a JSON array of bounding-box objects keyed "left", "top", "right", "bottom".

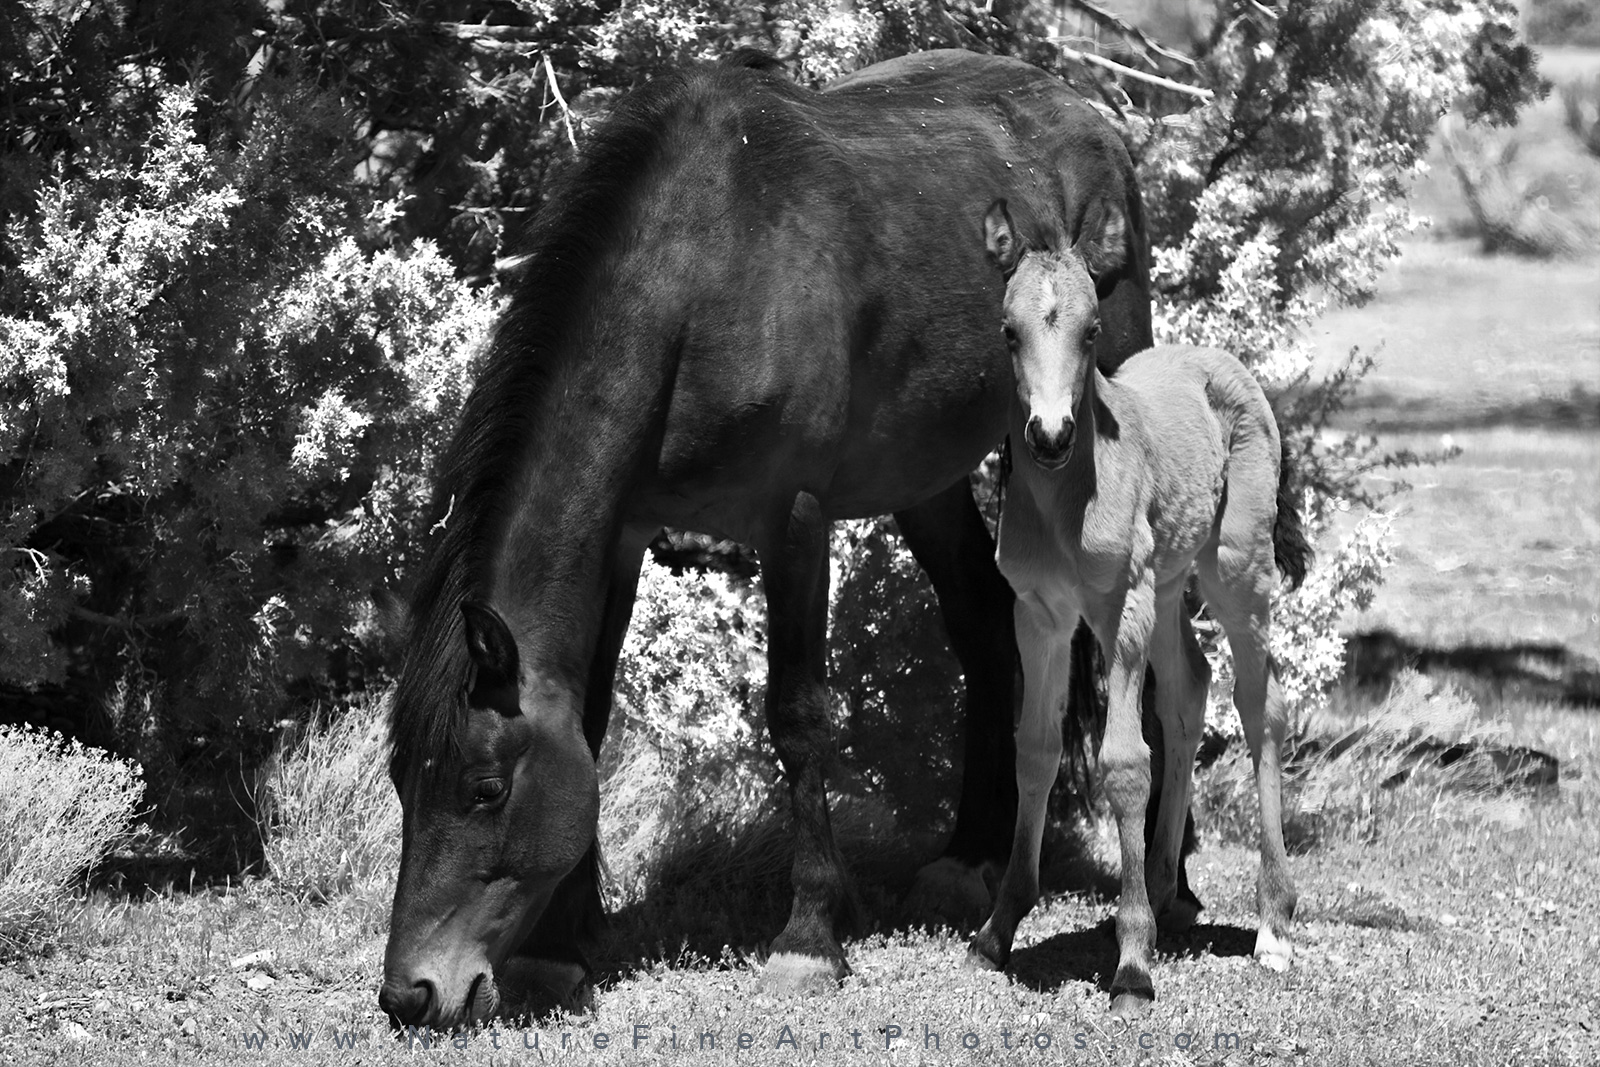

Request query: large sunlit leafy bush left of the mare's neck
[{"left": 0, "top": 75, "right": 494, "bottom": 780}]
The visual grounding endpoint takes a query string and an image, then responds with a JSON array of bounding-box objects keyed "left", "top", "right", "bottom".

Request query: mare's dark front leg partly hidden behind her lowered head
[{"left": 499, "top": 528, "right": 654, "bottom": 1009}]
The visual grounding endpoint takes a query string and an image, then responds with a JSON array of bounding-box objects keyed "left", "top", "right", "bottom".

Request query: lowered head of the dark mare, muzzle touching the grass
[{"left": 379, "top": 597, "right": 600, "bottom": 1029}]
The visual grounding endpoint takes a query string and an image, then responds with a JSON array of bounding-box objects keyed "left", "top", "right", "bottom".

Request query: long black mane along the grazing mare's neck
[{"left": 389, "top": 50, "right": 786, "bottom": 777}]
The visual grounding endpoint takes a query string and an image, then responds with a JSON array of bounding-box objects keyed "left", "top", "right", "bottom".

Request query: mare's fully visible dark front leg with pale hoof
[{"left": 758, "top": 493, "right": 856, "bottom": 993}]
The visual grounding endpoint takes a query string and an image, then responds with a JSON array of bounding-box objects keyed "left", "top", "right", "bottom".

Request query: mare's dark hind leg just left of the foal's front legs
[{"left": 894, "top": 478, "right": 1016, "bottom": 921}]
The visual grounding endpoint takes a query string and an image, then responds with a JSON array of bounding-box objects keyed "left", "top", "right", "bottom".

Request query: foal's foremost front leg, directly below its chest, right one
[{"left": 1091, "top": 571, "right": 1155, "bottom": 1017}]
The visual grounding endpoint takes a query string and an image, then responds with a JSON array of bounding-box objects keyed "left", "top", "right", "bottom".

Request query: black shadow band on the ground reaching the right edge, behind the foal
[{"left": 1344, "top": 630, "right": 1600, "bottom": 707}]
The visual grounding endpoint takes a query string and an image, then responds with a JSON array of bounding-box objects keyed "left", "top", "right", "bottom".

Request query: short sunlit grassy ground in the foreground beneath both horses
[{"left": 0, "top": 726, "right": 1600, "bottom": 1067}]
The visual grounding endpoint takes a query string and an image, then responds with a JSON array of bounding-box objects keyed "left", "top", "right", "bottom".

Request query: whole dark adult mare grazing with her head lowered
[{"left": 379, "top": 51, "right": 1150, "bottom": 1025}]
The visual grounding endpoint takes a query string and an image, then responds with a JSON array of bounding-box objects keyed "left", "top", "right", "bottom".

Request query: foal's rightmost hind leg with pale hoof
[{"left": 1198, "top": 556, "right": 1296, "bottom": 971}]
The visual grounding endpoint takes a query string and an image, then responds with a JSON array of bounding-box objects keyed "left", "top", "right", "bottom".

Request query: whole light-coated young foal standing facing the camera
[{"left": 973, "top": 202, "right": 1306, "bottom": 1014}]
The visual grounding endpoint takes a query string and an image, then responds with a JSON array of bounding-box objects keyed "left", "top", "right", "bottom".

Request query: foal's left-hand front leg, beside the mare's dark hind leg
[{"left": 966, "top": 592, "right": 1078, "bottom": 969}]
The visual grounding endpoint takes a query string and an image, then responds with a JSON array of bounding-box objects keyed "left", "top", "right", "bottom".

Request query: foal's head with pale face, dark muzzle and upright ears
[{"left": 984, "top": 200, "right": 1126, "bottom": 470}]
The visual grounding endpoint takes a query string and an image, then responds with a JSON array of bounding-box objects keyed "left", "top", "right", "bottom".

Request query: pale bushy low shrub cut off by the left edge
[{"left": 0, "top": 726, "right": 144, "bottom": 950}]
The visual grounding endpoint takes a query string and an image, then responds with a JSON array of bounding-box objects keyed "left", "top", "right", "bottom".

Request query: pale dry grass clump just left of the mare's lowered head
[{"left": 256, "top": 699, "right": 400, "bottom": 902}]
